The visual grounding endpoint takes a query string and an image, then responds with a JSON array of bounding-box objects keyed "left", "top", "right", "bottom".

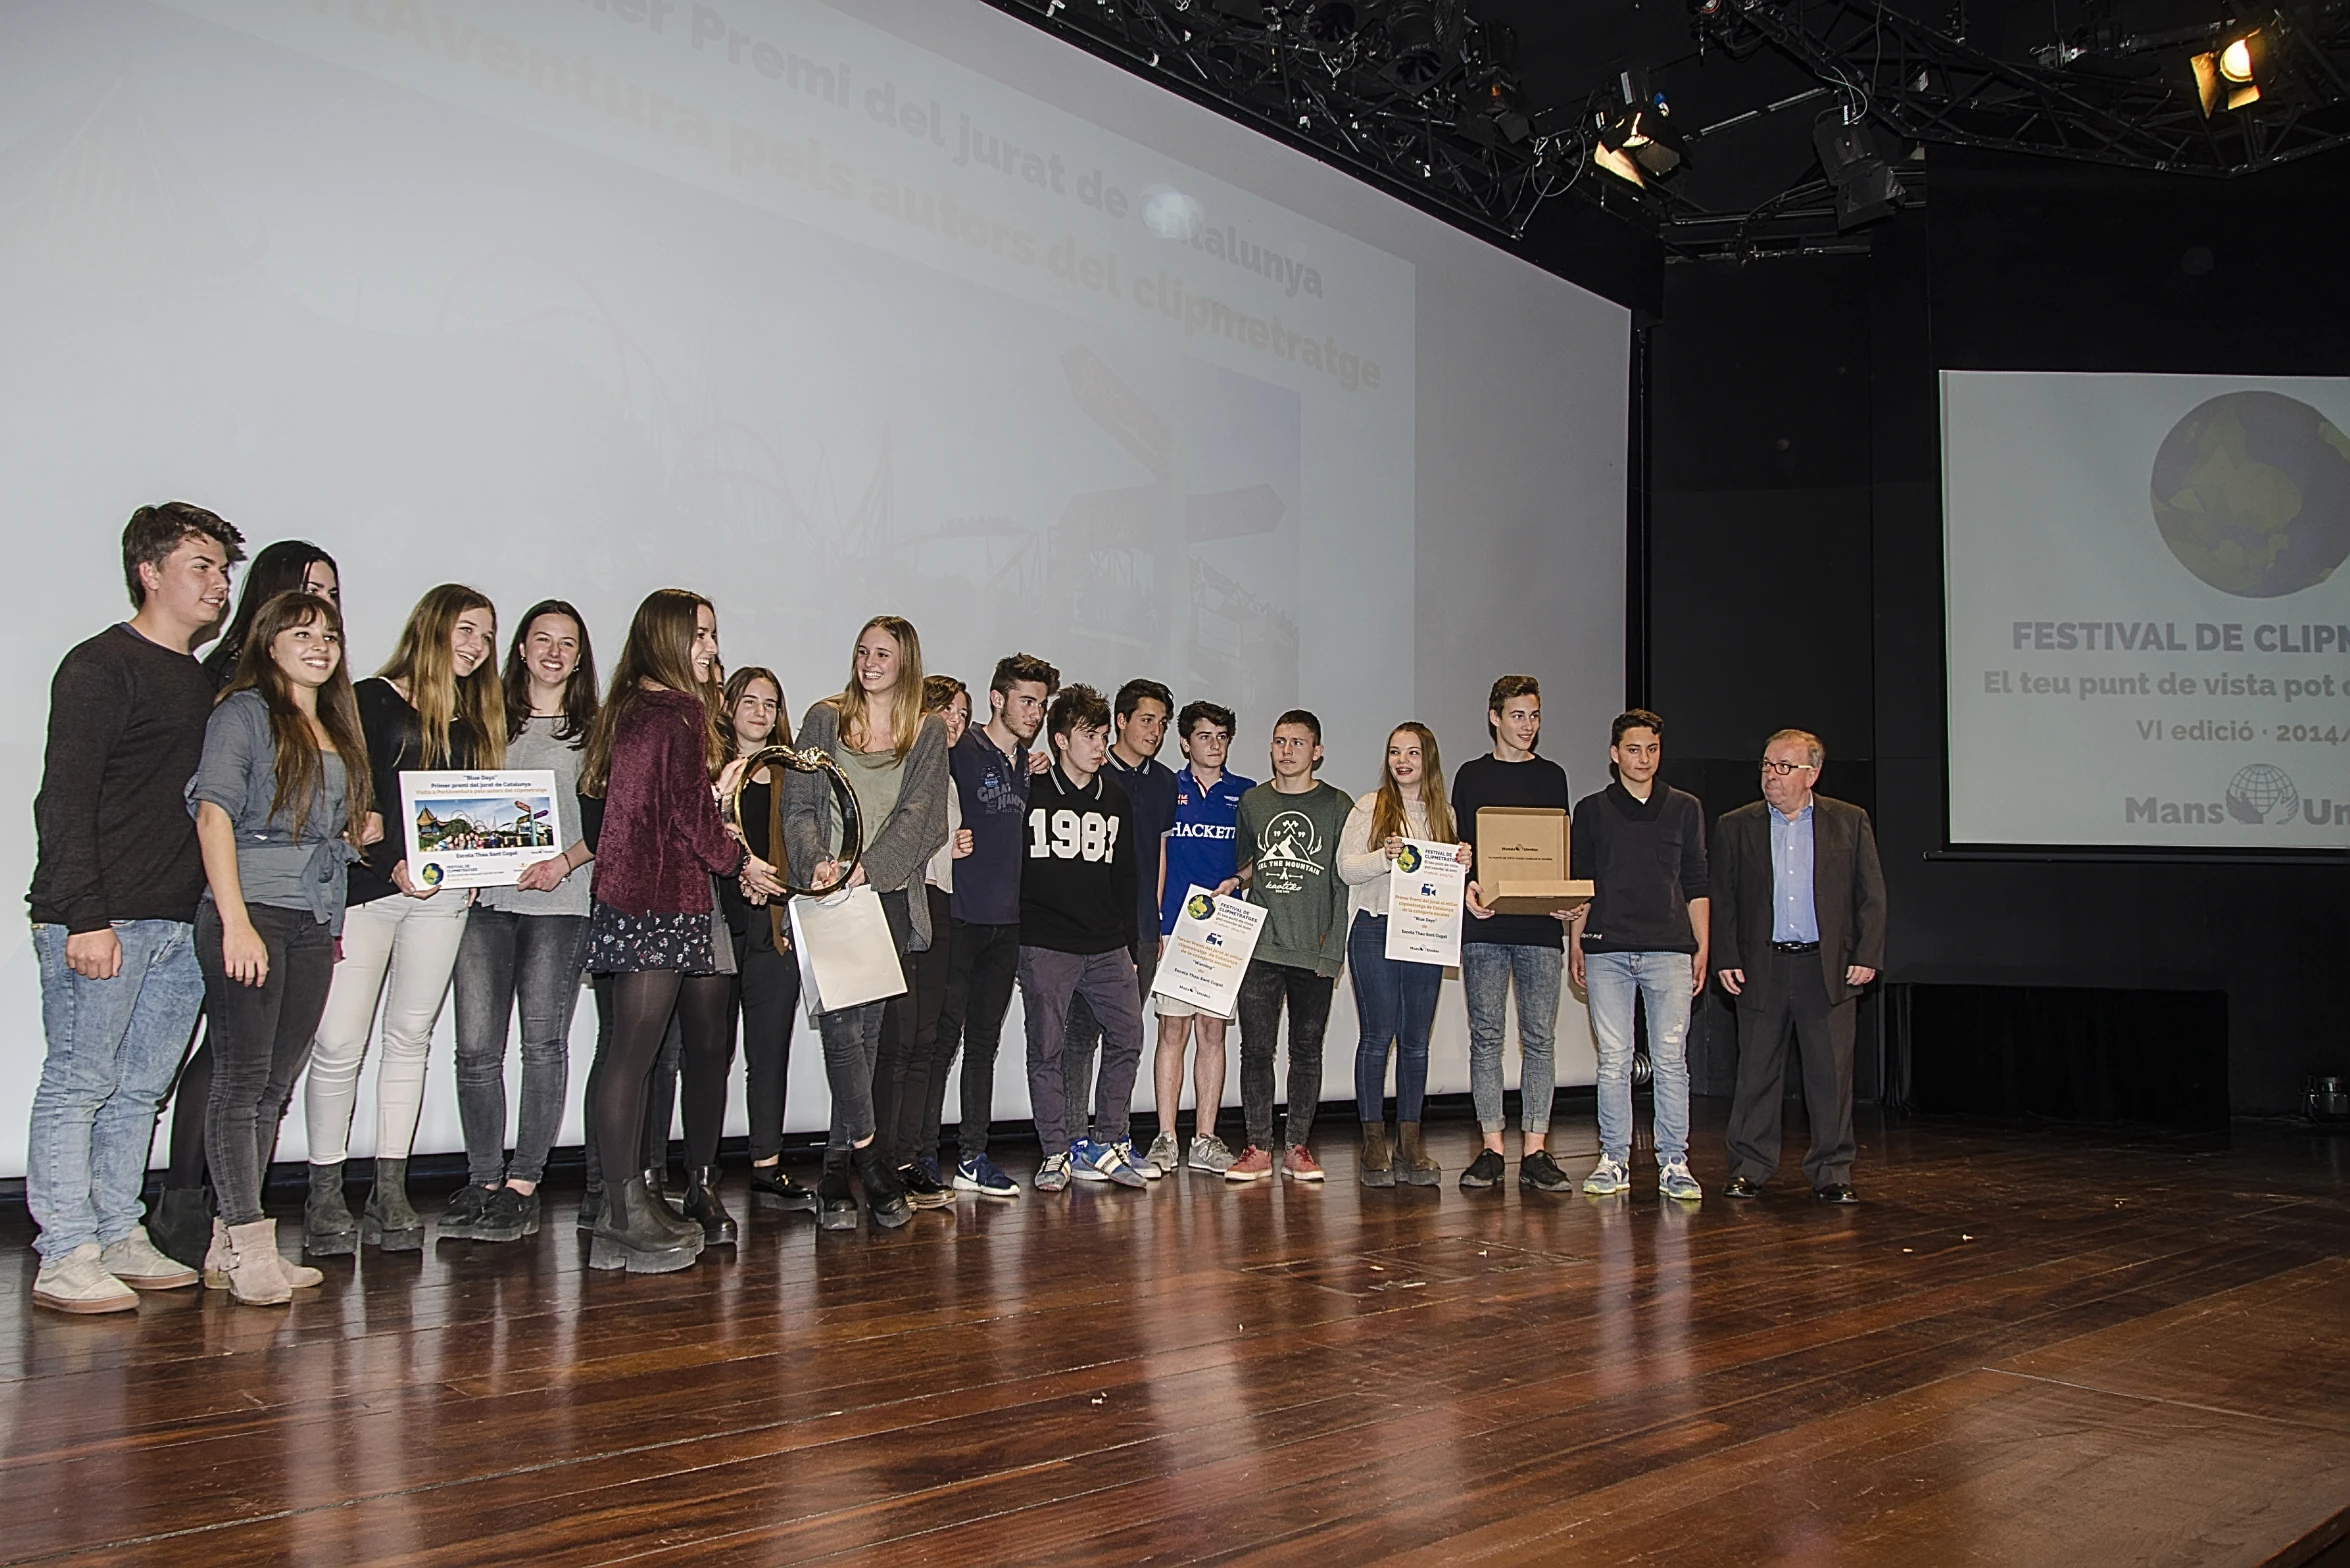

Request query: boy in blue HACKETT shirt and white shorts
[{"left": 1149, "top": 703, "right": 1257, "bottom": 1175}]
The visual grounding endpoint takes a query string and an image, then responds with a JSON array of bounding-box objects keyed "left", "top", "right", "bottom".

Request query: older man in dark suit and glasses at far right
[{"left": 1713, "top": 729, "right": 1885, "bottom": 1204}]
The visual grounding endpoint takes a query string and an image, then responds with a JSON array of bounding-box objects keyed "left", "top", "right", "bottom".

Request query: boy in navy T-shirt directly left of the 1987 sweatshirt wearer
[{"left": 924, "top": 654, "right": 1060, "bottom": 1199}]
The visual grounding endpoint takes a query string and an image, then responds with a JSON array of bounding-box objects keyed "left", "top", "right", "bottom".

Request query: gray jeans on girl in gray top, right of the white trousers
[{"left": 456, "top": 905, "right": 588, "bottom": 1187}]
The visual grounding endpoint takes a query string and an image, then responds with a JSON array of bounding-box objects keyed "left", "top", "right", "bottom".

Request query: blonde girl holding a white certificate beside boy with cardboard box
[{"left": 1337, "top": 722, "right": 1469, "bottom": 1187}]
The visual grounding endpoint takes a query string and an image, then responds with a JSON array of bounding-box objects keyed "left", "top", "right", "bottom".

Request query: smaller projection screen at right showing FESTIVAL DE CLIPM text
[{"left": 1941, "top": 371, "right": 2350, "bottom": 851}]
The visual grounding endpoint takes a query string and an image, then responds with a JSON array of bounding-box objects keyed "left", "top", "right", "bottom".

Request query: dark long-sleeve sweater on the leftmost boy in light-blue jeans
[{"left": 26, "top": 623, "right": 212, "bottom": 936}]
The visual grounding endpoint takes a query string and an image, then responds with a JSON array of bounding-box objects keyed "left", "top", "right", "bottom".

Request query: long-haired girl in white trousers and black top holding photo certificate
[{"left": 303, "top": 583, "right": 505, "bottom": 1255}]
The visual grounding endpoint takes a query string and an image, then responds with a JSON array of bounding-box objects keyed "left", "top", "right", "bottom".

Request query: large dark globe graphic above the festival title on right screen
[{"left": 2153, "top": 393, "right": 2350, "bottom": 599}]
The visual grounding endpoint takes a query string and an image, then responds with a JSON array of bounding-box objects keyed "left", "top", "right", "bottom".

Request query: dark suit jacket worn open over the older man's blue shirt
[{"left": 1711, "top": 795, "right": 1885, "bottom": 1004}]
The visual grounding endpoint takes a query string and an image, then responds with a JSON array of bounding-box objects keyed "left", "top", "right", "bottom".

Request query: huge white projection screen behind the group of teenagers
[{"left": 0, "top": 0, "right": 1629, "bottom": 1173}]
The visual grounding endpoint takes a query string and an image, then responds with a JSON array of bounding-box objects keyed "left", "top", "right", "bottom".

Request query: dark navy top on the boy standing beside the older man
[{"left": 1567, "top": 783, "right": 1708, "bottom": 952}]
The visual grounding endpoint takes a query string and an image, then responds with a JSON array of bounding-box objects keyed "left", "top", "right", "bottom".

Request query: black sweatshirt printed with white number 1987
[{"left": 1020, "top": 766, "right": 1135, "bottom": 954}]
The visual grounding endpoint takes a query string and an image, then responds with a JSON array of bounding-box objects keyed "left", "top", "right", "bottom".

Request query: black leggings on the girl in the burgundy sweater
[{"left": 595, "top": 969, "right": 733, "bottom": 1192}]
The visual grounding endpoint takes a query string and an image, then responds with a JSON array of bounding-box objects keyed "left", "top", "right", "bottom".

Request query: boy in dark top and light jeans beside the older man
[{"left": 1567, "top": 708, "right": 1713, "bottom": 1199}]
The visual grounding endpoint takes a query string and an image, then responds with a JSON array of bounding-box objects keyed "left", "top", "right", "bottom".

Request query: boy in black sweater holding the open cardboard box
[{"left": 1452, "top": 675, "right": 1575, "bottom": 1192}]
